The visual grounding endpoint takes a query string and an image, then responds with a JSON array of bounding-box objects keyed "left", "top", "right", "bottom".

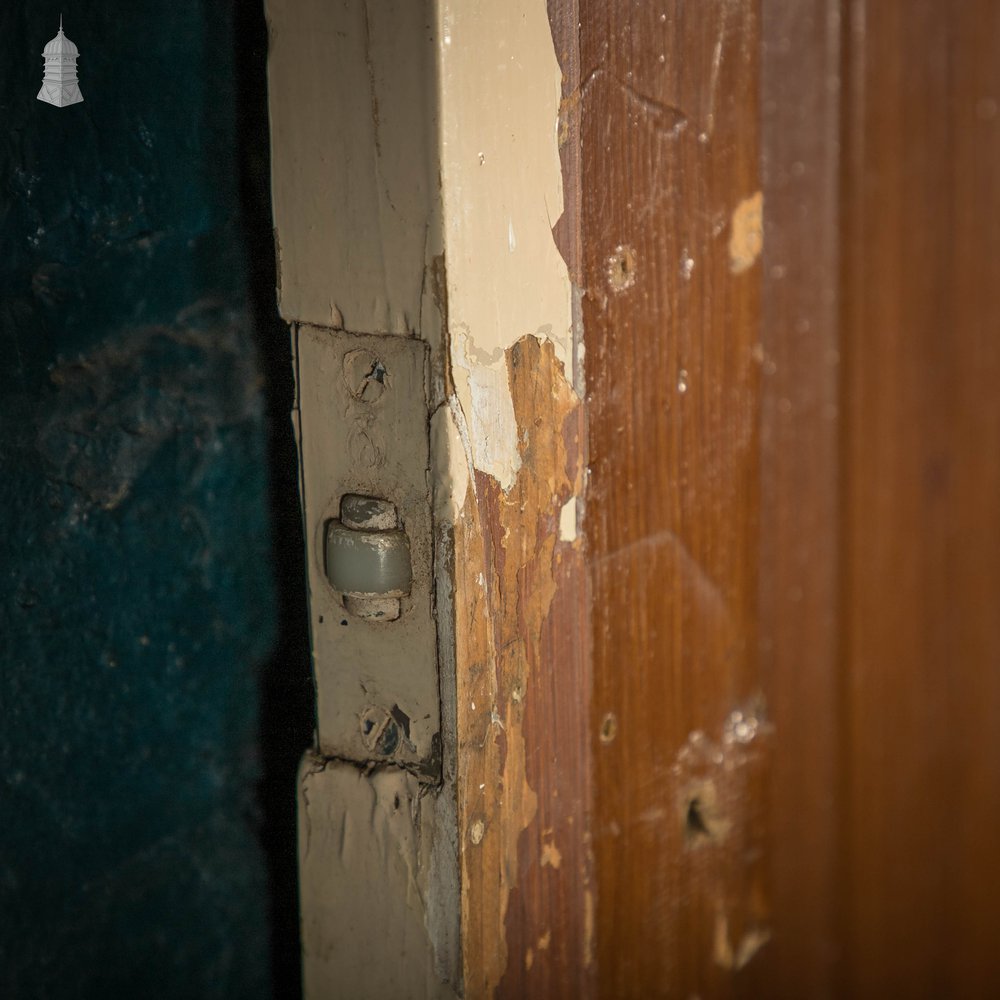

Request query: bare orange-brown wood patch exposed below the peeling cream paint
[{"left": 455, "top": 337, "right": 580, "bottom": 996}]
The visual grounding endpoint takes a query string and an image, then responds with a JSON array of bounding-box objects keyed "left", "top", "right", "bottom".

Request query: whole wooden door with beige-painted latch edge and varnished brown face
[{"left": 269, "top": 0, "right": 1000, "bottom": 998}]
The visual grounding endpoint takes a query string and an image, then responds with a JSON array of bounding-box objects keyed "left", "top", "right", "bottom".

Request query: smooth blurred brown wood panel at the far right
[{"left": 843, "top": 0, "right": 1000, "bottom": 997}]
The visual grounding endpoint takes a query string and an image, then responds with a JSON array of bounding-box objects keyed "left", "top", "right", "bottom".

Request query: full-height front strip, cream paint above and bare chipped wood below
[{"left": 437, "top": 0, "right": 592, "bottom": 998}]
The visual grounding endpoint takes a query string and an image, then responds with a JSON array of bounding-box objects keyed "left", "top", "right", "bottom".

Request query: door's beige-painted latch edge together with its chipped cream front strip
[{"left": 266, "top": 0, "right": 592, "bottom": 1000}]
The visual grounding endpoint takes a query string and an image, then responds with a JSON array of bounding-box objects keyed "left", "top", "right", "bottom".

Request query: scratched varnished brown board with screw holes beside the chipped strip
[{"left": 580, "top": 0, "right": 770, "bottom": 997}]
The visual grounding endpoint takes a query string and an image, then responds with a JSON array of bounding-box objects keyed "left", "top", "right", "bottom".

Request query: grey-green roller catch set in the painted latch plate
[{"left": 326, "top": 493, "right": 413, "bottom": 621}]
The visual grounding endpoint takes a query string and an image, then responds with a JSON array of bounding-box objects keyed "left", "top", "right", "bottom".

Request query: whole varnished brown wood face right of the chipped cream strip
[{"left": 580, "top": 0, "right": 1000, "bottom": 997}]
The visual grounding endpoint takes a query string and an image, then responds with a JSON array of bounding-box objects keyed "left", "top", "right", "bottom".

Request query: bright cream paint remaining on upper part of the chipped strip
[{"left": 437, "top": 0, "right": 572, "bottom": 496}]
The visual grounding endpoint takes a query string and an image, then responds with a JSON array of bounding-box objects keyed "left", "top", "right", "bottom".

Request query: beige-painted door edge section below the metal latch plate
[{"left": 299, "top": 754, "right": 460, "bottom": 1000}]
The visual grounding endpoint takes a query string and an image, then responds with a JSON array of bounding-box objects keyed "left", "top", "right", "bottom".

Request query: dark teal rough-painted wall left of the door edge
[{"left": 0, "top": 0, "right": 290, "bottom": 998}]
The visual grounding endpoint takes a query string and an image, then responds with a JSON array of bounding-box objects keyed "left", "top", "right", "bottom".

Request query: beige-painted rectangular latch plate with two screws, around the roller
[{"left": 296, "top": 325, "right": 441, "bottom": 780}]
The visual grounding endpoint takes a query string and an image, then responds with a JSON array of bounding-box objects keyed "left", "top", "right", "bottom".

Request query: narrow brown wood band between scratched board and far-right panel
[{"left": 752, "top": 0, "right": 842, "bottom": 998}]
